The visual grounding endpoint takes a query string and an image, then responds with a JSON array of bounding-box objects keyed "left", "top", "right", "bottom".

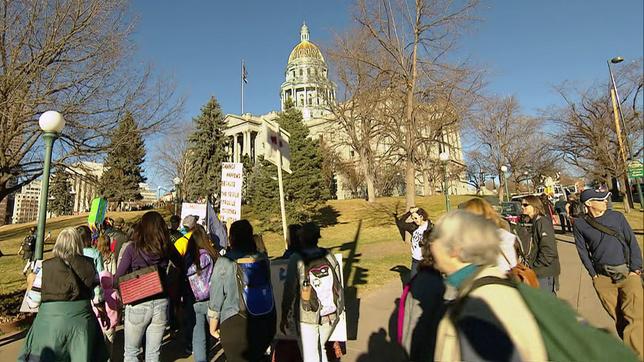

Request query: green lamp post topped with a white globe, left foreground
[{"left": 34, "top": 111, "right": 65, "bottom": 260}]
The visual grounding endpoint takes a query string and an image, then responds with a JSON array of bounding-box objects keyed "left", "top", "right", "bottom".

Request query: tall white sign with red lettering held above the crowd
[{"left": 219, "top": 162, "right": 244, "bottom": 221}]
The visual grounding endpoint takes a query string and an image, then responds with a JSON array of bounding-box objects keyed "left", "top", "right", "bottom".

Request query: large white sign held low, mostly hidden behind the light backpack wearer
[{"left": 271, "top": 254, "right": 347, "bottom": 341}]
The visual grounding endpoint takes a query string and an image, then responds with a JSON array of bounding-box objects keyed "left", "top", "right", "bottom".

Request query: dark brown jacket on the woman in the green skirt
[{"left": 41, "top": 255, "right": 98, "bottom": 302}]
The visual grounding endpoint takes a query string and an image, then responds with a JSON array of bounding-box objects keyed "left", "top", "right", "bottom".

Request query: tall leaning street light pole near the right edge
[{"left": 606, "top": 57, "right": 642, "bottom": 212}]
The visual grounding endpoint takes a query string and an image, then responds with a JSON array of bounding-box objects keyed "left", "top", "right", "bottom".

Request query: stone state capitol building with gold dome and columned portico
[{"left": 224, "top": 24, "right": 473, "bottom": 199}]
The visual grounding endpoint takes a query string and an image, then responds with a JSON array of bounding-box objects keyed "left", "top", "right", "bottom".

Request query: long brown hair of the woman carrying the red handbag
[{"left": 132, "top": 211, "right": 170, "bottom": 257}]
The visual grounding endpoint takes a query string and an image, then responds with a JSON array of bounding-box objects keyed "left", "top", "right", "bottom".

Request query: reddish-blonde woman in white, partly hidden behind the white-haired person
[{"left": 460, "top": 197, "right": 517, "bottom": 271}]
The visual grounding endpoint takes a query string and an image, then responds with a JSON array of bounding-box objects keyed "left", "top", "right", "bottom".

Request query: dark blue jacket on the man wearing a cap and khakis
[{"left": 573, "top": 210, "right": 642, "bottom": 277}]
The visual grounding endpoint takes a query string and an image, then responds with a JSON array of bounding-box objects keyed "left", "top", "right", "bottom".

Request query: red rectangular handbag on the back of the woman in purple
[{"left": 119, "top": 250, "right": 164, "bottom": 304}]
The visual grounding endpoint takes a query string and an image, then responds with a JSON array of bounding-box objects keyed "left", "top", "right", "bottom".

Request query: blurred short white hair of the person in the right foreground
[{"left": 431, "top": 210, "right": 501, "bottom": 265}]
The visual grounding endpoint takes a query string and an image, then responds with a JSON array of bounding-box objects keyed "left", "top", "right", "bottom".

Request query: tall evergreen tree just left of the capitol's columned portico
[{"left": 184, "top": 97, "right": 228, "bottom": 201}]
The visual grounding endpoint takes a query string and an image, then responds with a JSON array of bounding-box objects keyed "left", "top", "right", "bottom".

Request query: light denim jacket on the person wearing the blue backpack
[{"left": 208, "top": 250, "right": 260, "bottom": 324}]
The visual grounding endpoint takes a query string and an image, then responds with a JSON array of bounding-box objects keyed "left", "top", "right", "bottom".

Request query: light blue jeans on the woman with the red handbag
[{"left": 123, "top": 298, "right": 168, "bottom": 362}]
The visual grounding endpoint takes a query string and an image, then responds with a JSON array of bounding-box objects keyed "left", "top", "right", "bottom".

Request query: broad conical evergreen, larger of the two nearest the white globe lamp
[{"left": 100, "top": 112, "right": 146, "bottom": 206}]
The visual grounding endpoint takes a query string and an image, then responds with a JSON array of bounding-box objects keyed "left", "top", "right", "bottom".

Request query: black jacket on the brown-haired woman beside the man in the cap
[{"left": 528, "top": 215, "right": 560, "bottom": 278}]
